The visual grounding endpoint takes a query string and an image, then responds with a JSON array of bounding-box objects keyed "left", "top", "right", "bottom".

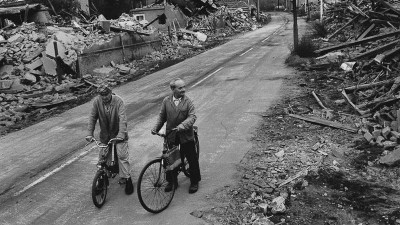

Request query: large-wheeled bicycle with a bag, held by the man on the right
[{"left": 137, "top": 126, "right": 200, "bottom": 213}]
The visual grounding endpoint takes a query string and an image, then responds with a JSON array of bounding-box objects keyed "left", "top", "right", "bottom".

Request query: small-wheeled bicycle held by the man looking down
[{"left": 88, "top": 138, "right": 133, "bottom": 208}]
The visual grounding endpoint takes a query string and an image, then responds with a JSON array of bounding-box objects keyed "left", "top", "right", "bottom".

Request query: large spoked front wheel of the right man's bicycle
[{"left": 137, "top": 159, "right": 175, "bottom": 213}]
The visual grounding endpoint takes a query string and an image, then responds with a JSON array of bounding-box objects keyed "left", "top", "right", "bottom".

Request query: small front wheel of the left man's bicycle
[{"left": 92, "top": 170, "right": 108, "bottom": 208}]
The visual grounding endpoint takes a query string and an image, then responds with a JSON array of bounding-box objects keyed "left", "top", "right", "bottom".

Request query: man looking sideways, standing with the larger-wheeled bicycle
[{"left": 151, "top": 78, "right": 201, "bottom": 193}]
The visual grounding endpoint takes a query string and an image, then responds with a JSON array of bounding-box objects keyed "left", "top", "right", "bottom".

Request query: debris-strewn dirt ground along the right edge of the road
[{"left": 193, "top": 69, "right": 400, "bottom": 225}]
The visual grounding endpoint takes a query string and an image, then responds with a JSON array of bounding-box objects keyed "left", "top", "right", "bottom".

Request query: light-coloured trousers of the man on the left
[{"left": 99, "top": 141, "right": 131, "bottom": 178}]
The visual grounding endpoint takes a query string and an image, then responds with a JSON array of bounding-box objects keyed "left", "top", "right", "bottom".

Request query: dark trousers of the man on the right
[{"left": 166, "top": 140, "right": 201, "bottom": 184}]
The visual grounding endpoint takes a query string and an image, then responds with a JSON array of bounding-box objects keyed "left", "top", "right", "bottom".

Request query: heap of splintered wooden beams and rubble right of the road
[{"left": 289, "top": 1, "right": 400, "bottom": 163}]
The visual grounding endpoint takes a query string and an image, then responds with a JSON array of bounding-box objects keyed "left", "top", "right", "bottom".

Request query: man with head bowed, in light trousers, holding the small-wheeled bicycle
[{"left": 86, "top": 84, "right": 133, "bottom": 194}]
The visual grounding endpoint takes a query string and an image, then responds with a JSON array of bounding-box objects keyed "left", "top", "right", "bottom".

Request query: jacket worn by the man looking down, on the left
[{"left": 88, "top": 95, "right": 128, "bottom": 143}]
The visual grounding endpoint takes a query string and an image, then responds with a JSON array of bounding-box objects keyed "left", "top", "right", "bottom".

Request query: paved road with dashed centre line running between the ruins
[{"left": 0, "top": 13, "right": 301, "bottom": 224}]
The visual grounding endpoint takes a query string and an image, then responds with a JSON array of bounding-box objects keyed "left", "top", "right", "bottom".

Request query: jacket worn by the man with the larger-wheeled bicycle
[{"left": 153, "top": 95, "right": 197, "bottom": 144}]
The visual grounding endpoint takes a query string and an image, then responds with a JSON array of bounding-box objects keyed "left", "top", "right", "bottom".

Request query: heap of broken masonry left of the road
[{"left": 0, "top": 15, "right": 159, "bottom": 134}]
